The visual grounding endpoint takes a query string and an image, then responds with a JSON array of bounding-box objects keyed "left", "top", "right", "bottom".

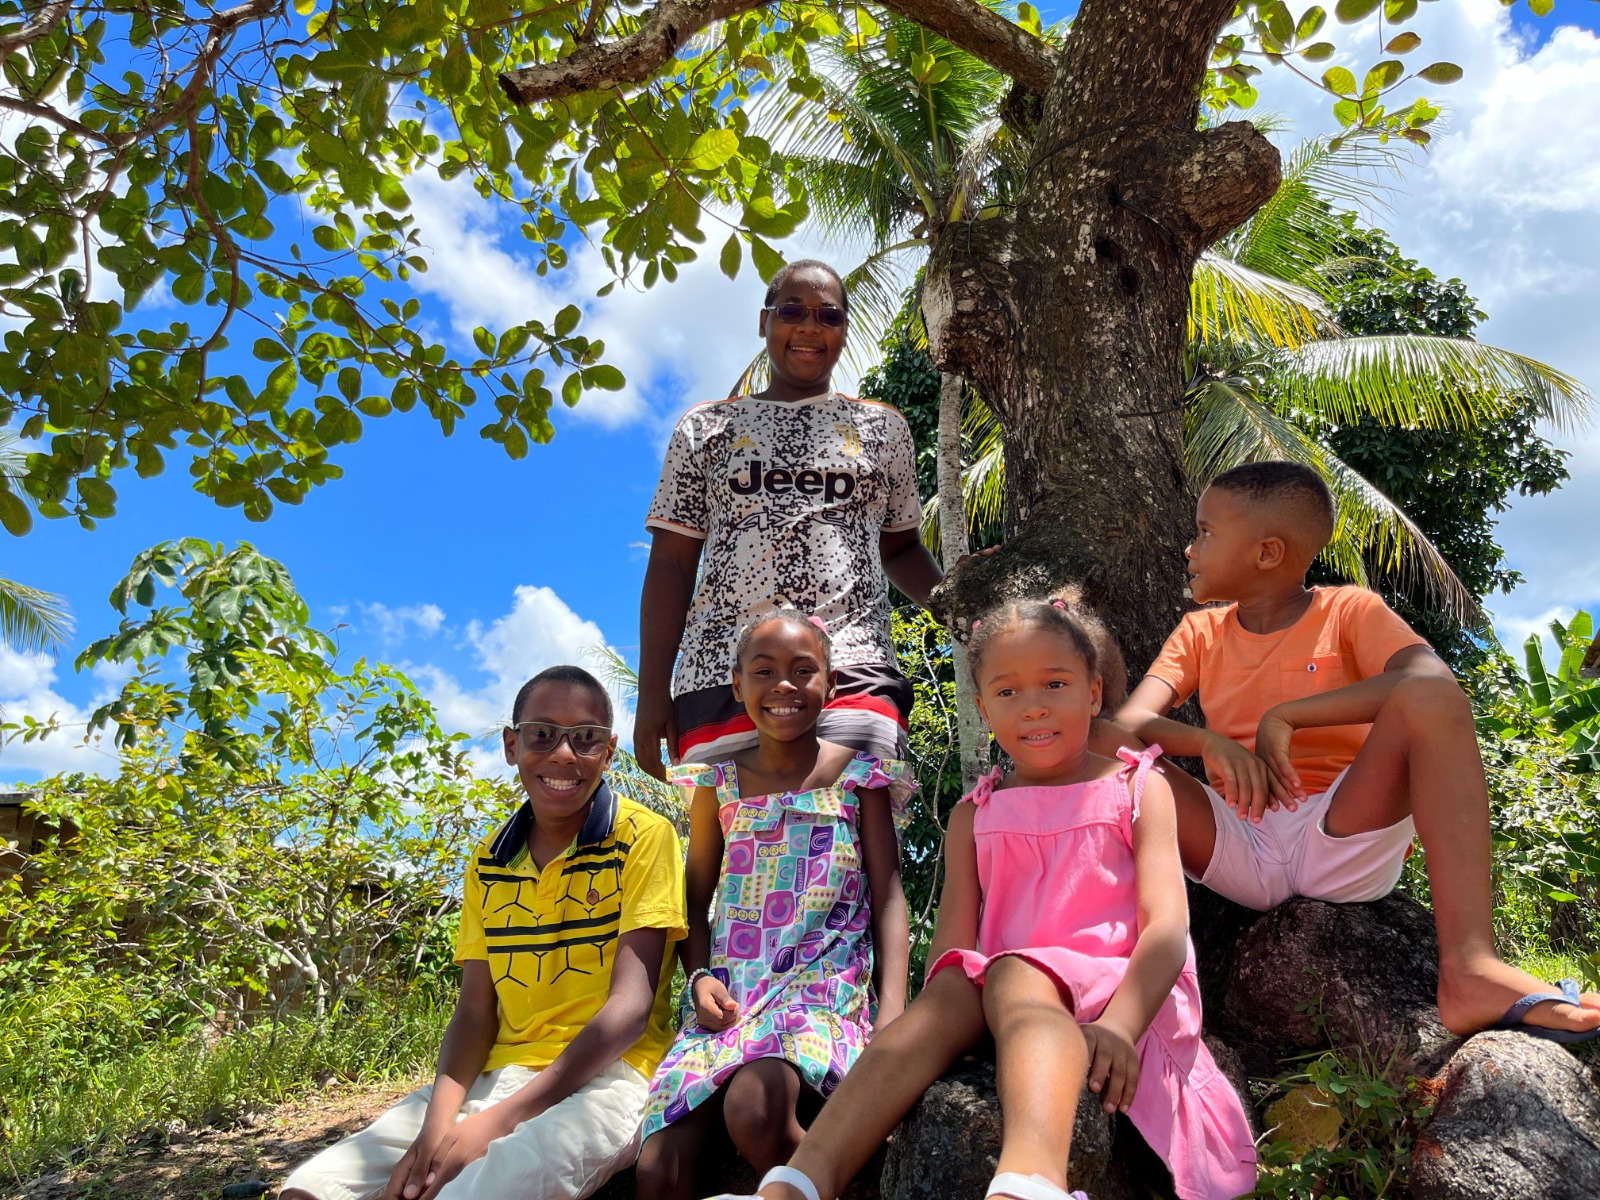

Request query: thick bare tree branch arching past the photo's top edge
[{"left": 499, "top": 0, "right": 1056, "bottom": 104}]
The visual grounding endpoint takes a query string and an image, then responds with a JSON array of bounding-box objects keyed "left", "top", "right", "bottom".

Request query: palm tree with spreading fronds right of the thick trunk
[{"left": 925, "top": 141, "right": 1589, "bottom": 627}]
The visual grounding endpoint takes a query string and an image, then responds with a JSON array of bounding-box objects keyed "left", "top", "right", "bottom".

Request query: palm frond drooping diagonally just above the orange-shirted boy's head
[{"left": 1184, "top": 379, "right": 1485, "bottom": 627}]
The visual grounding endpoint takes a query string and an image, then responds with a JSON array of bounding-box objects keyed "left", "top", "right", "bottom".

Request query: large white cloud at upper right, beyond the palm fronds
[{"left": 1258, "top": 0, "right": 1600, "bottom": 630}]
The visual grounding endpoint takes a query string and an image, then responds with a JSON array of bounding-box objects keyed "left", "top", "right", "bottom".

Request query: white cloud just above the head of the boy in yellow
[{"left": 402, "top": 584, "right": 634, "bottom": 771}]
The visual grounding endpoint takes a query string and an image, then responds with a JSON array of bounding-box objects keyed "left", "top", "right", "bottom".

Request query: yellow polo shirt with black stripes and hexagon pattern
[{"left": 456, "top": 782, "right": 688, "bottom": 1078}]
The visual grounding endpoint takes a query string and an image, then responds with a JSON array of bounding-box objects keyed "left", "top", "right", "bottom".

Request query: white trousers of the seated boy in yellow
[{"left": 283, "top": 1059, "right": 650, "bottom": 1200}]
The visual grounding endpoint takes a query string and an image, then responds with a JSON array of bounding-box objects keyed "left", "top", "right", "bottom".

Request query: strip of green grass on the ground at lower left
[{"left": 0, "top": 986, "right": 454, "bottom": 1184}]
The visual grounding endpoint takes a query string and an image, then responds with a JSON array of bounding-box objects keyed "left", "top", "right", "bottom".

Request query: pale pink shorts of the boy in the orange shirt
[{"left": 1198, "top": 768, "right": 1416, "bottom": 912}]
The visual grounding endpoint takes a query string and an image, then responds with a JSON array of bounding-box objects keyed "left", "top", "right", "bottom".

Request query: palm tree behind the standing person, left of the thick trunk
[{"left": 741, "top": 18, "right": 1026, "bottom": 787}]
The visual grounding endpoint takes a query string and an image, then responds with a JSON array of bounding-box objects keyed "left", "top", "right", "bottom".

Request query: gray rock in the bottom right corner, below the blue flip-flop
[{"left": 1411, "top": 1032, "right": 1600, "bottom": 1200}]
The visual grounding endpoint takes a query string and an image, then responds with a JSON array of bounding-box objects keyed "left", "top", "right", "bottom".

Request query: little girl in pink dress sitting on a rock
[{"left": 716, "top": 598, "right": 1256, "bottom": 1200}]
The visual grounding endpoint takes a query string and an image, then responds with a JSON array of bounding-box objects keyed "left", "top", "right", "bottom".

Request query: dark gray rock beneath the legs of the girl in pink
[{"left": 882, "top": 1061, "right": 1125, "bottom": 1200}]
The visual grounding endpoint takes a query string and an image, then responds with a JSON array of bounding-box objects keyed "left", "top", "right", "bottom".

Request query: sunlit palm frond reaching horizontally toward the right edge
[{"left": 1261, "top": 334, "right": 1590, "bottom": 430}]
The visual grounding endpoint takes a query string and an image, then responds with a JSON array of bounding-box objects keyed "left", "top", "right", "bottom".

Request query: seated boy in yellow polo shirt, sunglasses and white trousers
[{"left": 282, "top": 666, "right": 686, "bottom": 1200}]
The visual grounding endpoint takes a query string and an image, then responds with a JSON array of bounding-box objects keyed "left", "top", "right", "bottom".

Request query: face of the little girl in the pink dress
[{"left": 976, "top": 626, "right": 1101, "bottom": 778}]
